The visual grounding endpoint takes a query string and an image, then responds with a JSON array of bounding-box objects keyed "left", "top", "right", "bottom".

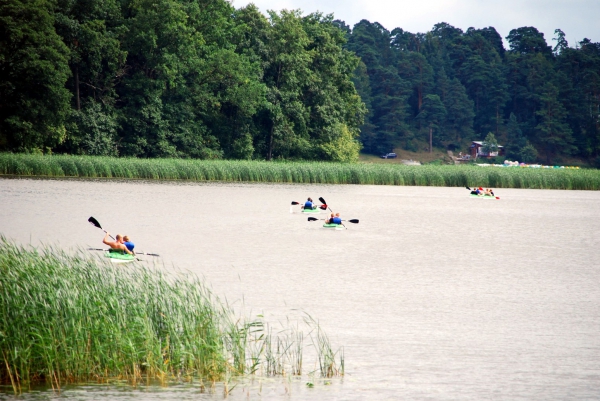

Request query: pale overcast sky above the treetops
[{"left": 233, "top": 0, "right": 600, "bottom": 47}]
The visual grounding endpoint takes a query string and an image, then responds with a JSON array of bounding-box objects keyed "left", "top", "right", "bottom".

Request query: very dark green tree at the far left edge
[{"left": 0, "top": 0, "right": 71, "bottom": 151}]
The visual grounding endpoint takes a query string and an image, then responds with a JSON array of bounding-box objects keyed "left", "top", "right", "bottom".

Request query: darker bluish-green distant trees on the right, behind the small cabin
[{"left": 342, "top": 20, "right": 600, "bottom": 163}]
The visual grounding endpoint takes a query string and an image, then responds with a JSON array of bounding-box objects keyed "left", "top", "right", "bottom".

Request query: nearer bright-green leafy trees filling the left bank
[{"left": 0, "top": 0, "right": 366, "bottom": 161}]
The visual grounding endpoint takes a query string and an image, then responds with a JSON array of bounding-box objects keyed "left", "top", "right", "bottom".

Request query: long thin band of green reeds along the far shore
[{"left": 0, "top": 153, "right": 600, "bottom": 190}]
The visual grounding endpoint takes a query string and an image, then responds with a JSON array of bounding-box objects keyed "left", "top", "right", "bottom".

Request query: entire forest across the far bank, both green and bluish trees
[{"left": 0, "top": 0, "right": 600, "bottom": 163}]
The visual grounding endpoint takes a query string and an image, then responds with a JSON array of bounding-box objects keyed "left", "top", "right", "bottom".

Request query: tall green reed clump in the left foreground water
[{"left": 0, "top": 237, "right": 344, "bottom": 393}]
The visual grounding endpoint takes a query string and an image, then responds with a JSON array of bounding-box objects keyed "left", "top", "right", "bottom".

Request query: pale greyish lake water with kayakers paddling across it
[{"left": 0, "top": 179, "right": 600, "bottom": 400}]
